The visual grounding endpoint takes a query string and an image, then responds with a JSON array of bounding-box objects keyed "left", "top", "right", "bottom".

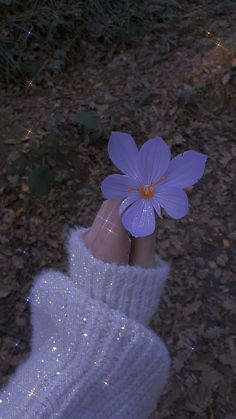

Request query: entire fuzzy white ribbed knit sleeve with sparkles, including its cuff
[{"left": 0, "top": 226, "right": 170, "bottom": 419}]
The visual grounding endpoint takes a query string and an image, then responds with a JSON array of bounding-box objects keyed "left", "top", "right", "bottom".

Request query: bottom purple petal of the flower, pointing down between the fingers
[{"left": 121, "top": 199, "right": 156, "bottom": 237}]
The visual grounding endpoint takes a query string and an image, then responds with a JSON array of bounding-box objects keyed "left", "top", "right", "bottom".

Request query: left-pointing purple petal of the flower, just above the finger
[{"left": 101, "top": 174, "right": 137, "bottom": 199}]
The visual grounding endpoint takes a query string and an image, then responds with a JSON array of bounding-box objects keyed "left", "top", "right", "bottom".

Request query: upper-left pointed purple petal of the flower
[{"left": 108, "top": 131, "right": 139, "bottom": 178}]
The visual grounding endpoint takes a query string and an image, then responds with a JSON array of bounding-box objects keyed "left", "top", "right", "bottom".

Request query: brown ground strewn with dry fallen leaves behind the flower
[{"left": 0, "top": 4, "right": 236, "bottom": 419}]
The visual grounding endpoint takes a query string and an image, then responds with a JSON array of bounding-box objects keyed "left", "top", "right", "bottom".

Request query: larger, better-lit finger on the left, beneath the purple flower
[{"left": 83, "top": 199, "right": 130, "bottom": 265}]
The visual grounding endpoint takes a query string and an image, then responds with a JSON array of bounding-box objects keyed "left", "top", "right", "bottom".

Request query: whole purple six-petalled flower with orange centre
[{"left": 101, "top": 131, "right": 208, "bottom": 237}]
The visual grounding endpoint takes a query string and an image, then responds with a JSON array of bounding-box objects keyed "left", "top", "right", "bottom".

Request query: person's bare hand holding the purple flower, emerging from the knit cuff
[{"left": 83, "top": 187, "right": 193, "bottom": 268}]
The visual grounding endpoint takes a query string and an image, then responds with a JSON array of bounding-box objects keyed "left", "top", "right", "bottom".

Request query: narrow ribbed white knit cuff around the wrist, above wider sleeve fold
[{"left": 66, "top": 226, "right": 171, "bottom": 325}]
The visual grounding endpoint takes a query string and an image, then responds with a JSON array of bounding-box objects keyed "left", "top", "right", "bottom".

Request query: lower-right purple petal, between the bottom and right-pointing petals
[{"left": 155, "top": 185, "right": 189, "bottom": 220}]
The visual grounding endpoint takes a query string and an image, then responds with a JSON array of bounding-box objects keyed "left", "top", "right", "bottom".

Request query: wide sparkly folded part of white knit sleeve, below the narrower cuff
[{"left": 0, "top": 269, "right": 170, "bottom": 419}]
